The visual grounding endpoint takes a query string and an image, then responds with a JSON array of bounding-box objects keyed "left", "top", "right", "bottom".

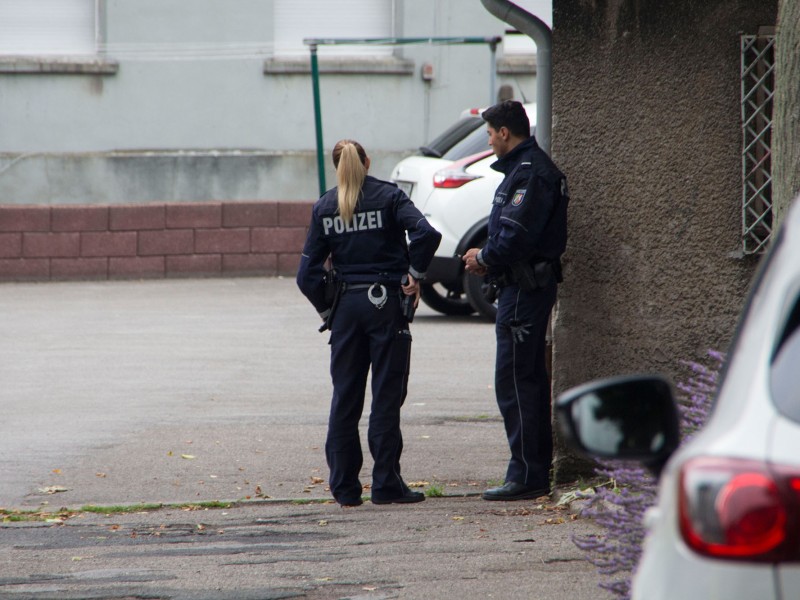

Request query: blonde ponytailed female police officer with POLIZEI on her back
[{"left": 297, "top": 140, "right": 442, "bottom": 506}]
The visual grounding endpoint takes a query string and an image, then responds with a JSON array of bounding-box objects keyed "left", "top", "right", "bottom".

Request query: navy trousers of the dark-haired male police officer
[{"left": 495, "top": 282, "right": 556, "bottom": 489}]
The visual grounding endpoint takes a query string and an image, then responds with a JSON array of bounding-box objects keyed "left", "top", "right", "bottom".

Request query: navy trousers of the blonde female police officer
[{"left": 325, "top": 288, "right": 411, "bottom": 503}]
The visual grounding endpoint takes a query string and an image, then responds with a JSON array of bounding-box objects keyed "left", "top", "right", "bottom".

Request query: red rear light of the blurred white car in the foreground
[{"left": 679, "top": 457, "right": 800, "bottom": 562}]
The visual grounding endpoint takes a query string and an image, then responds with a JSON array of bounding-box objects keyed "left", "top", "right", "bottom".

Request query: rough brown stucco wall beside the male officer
[{"left": 553, "top": 0, "right": 777, "bottom": 478}]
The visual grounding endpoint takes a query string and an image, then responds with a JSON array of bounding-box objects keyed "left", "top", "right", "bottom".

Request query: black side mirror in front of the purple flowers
[{"left": 556, "top": 375, "right": 680, "bottom": 475}]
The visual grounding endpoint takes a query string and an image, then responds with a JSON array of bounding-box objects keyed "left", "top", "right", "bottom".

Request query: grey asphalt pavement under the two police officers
[{"left": 0, "top": 278, "right": 609, "bottom": 600}]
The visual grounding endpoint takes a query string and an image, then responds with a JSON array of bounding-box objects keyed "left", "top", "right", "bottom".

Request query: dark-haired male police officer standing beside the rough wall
[{"left": 463, "top": 100, "right": 568, "bottom": 500}]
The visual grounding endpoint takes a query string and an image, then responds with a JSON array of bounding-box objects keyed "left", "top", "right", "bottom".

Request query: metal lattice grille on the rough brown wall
[{"left": 741, "top": 35, "right": 775, "bottom": 254}]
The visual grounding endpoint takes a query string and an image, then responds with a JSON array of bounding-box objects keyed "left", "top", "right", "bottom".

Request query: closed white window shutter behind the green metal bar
[{"left": 274, "top": 0, "right": 393, "bottom": 57}]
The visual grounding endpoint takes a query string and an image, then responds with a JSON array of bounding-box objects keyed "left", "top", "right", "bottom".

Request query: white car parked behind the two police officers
[{"left": 391, "top": 104, "right": 536, "bottom": 320}]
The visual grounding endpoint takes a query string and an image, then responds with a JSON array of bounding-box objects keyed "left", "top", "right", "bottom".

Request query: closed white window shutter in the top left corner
[{"left": 0, "top": 0, "right": 96, "bottom": 56}]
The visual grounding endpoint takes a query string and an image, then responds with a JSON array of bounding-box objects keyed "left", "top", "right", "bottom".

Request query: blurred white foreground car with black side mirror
[{"left": 557, "top": 200, "right": 800, "bottom": 600}]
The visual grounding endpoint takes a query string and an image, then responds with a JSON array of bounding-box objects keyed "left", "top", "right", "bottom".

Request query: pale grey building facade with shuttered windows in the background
[{"left": 0, "top": 0, "right": 551, "bottom": 205}]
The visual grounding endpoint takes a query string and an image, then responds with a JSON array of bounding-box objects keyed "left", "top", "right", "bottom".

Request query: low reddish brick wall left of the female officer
[{"left": 0, "top": 202, "right": 313, "bottom": 281}]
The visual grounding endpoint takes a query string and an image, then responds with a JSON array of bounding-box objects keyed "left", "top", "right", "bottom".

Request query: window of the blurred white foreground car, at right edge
[{"left": 770, "top": 298, "right": 800, "bottom": 423}]
